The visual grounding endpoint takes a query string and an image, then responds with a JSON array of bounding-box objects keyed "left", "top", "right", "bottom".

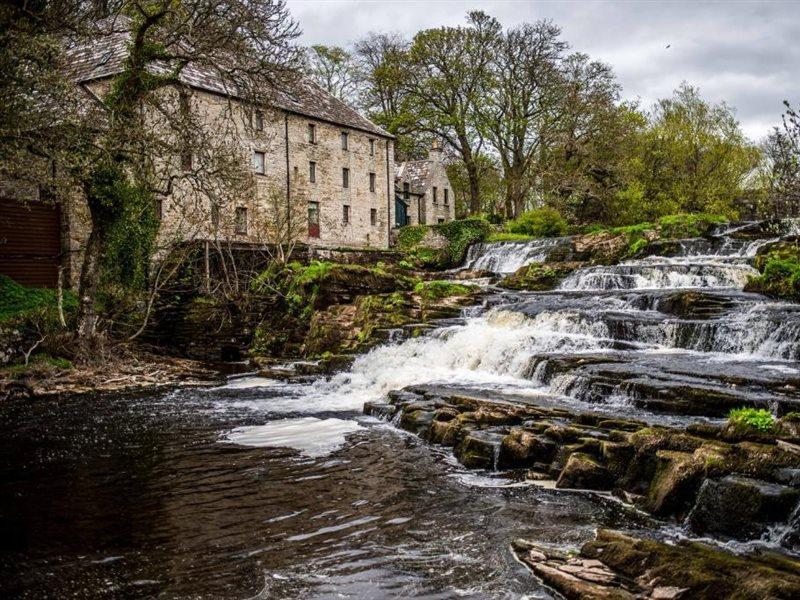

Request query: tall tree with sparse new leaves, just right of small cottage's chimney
[{"left": 406, "top": 11, "right": 500, "bottom": 214}]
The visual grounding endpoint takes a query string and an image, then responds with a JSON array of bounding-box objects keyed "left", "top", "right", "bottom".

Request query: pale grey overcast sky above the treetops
[{"left": 287, "top": 0, "right": 800, "bottom": 140}]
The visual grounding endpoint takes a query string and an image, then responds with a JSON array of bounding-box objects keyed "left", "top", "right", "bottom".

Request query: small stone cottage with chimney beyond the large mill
[{"left": 394, "top": 141, "right": 455, "bottom": 227}]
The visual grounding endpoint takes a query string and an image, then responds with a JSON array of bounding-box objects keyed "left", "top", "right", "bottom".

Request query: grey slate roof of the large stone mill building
[{"left": 67, "top": 19, "right": 393, "bottom": 138}]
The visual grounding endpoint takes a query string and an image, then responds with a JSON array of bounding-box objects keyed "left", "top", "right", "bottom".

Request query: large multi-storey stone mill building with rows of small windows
[{"left": 0, "top": 27, "right": 395, "bottom": 285}]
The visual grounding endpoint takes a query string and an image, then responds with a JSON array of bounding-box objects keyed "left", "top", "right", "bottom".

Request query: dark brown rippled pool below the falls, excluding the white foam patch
[{"left": 0, "top": 390, "right": 642, "bottom": 599}]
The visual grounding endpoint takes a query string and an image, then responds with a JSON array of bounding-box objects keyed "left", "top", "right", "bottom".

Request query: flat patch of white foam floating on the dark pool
[{"left": 223, "top": 417, "right": 363, "bottom": 457}]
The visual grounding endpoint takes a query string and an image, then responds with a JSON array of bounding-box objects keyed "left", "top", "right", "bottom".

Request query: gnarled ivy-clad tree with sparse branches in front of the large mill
[{"left": 50, "top": 0, "right": 298, "bottom": 338}]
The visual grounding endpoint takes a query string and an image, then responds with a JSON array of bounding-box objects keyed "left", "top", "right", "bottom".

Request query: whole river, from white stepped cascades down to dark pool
[{"left": 0, "top": 223, "right": 800, "bottom": 600}]
